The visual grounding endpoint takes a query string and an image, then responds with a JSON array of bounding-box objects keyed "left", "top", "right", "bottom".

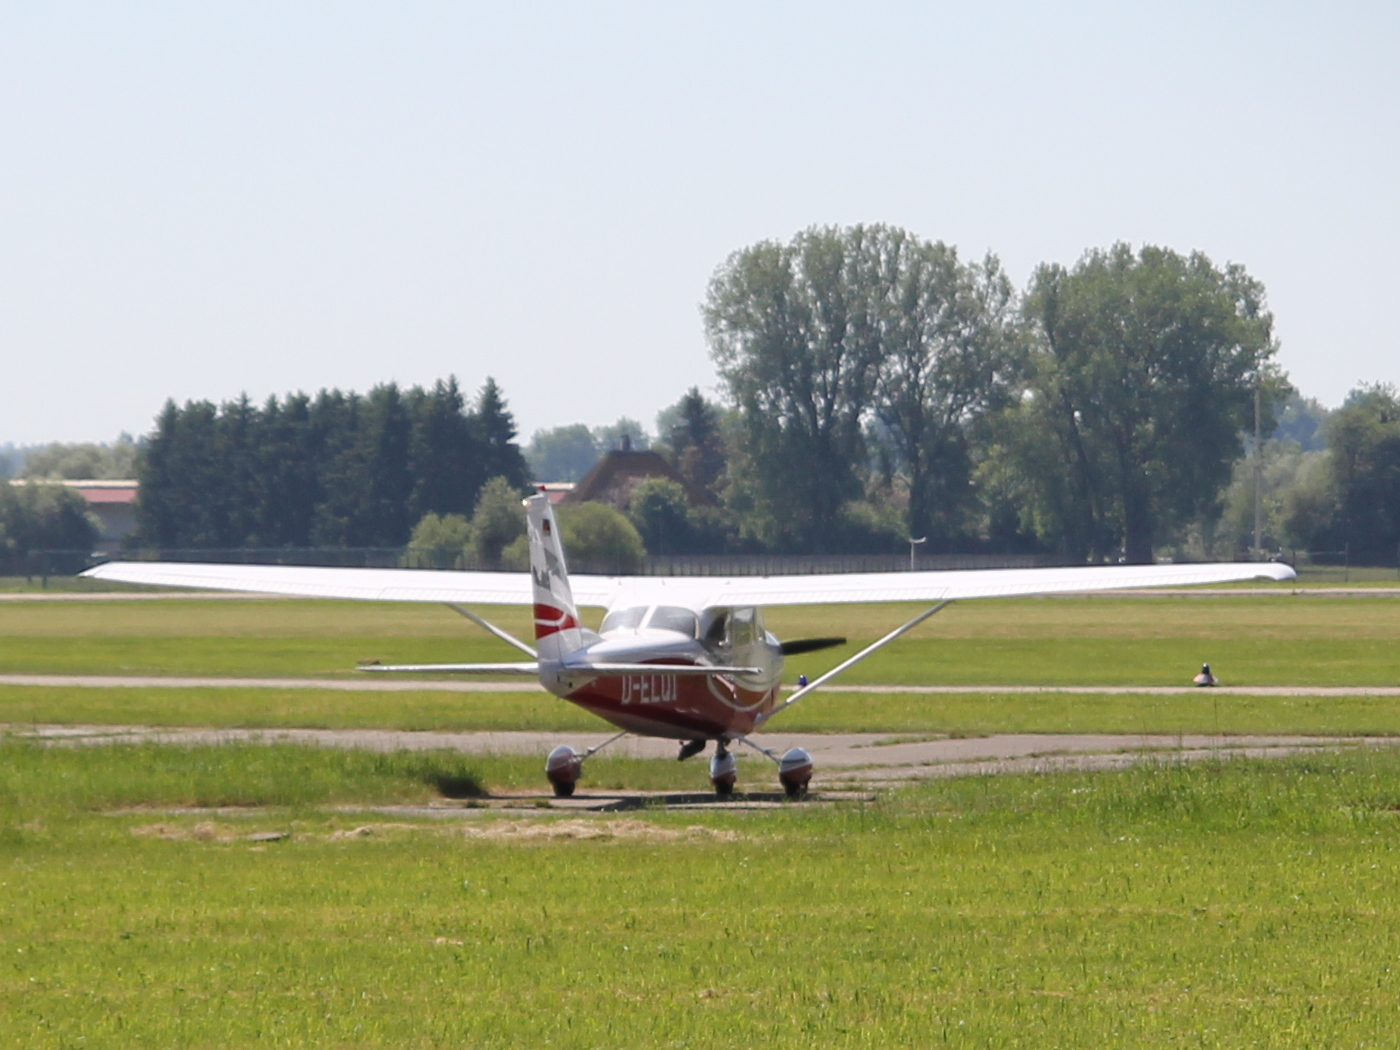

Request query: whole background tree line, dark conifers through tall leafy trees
[{"left": 10, "top": 225, "right": 1400, "bottom": 567}]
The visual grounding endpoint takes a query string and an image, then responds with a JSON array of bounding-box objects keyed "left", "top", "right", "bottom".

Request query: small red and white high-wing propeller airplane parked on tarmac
[{"left": 83, "top": 494, "right": 1295, "bottom": 799}]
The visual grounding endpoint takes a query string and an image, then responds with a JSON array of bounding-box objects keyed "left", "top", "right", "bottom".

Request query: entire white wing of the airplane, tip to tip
[{"left": 83, "top": 561, "right": 1296, "bottom": 609}]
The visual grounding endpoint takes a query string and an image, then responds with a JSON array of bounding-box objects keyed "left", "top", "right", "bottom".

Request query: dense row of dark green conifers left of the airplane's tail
[{"left": 136, "top": 378, "right": 529, "bottom": 547}]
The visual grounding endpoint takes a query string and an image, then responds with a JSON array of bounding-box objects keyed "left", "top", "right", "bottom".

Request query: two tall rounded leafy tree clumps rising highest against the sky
[{"left": 706, "top": 227, "right": 1282, "bottom": 561}]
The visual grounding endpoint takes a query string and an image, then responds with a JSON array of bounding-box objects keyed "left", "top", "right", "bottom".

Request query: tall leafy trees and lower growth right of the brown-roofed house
[{"left": 529, "top": 227, "right": 1400, "bottom": 561}]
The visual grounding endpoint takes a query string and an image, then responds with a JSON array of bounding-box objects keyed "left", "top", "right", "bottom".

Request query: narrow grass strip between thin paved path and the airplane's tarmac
[{"left": 13, "top": 686, "right": 1400, "bottom": 743}]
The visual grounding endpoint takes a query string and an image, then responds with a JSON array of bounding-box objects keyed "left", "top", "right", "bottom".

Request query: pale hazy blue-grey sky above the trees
[{"left": 0, "top": 0, "right": 1400, "bottom": 442}]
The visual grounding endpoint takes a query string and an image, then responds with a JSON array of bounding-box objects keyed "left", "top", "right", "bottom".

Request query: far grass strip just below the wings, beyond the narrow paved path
[{"left": 0, "top": 596, "right": 1400, "bottom": 686}]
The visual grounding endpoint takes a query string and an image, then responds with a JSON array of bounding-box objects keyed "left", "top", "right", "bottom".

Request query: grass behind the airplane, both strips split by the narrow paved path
[{"left": 0, "top": 596, "right": 1400, "bottom": 735}]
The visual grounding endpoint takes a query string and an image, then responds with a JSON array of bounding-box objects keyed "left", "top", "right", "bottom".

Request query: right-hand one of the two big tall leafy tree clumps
[{"left": 1009, "top": 244, "right": 1285, "bottom": 563}]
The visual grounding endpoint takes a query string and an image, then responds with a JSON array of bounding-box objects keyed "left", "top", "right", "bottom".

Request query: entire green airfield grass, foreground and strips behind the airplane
[{"left": 8, "top": 598, "right": 1400, "bottom": 1050}]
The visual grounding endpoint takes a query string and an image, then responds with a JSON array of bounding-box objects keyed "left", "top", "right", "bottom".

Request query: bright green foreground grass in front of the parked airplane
[{"left": 0, "top": 749, "right": 1400, "bottom": 1049}]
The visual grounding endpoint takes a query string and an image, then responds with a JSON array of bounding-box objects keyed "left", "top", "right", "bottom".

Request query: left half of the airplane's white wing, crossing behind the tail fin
[{"left": 83, "top": 561, "right": 619, "bottom": 606}]
